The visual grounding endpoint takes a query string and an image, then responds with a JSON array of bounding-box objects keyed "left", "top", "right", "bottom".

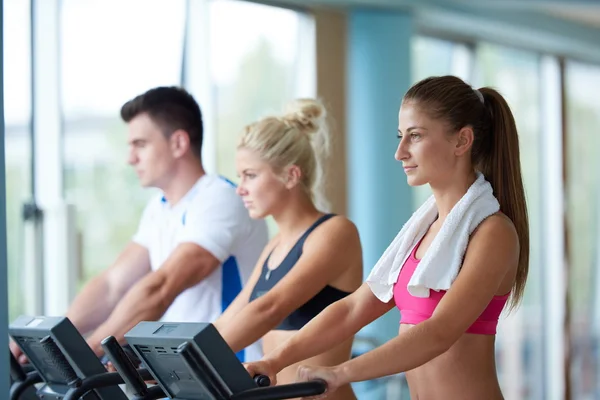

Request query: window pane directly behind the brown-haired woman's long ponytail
[{"left": 475, "top": 44, "right": 544, "bottom": 399}]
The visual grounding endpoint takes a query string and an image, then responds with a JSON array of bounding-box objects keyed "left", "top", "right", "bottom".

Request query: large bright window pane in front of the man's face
[{"left": 61, "top": 0, "right": 185, "bottom": 283}]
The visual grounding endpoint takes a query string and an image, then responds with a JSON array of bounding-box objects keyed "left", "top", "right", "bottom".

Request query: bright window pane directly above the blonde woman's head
[{"left": 210, "top": 0, "right": 316, "bottom": 234}]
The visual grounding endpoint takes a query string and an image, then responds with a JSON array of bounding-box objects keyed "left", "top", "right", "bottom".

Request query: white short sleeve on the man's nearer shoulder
[{"left": 177, "top": 182, "right": 251, "bottom": 262}]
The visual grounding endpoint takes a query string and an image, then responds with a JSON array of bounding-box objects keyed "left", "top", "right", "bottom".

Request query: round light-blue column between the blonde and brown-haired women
[{"left": 347, "top": 9, "right": 413, "bottom": 343}]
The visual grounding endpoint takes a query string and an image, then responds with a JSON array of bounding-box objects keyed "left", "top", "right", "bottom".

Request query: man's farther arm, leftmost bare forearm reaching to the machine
[{"left": 66, "top": 242, "right": 150, "bottom": 335}]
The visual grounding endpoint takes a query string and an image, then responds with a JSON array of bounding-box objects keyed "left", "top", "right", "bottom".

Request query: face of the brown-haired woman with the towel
[{"left": 395, "top": 102, "right": 468, "bottom": 186}]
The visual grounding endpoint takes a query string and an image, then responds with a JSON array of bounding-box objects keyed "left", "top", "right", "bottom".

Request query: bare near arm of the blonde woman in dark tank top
[{"left": 219, "top": 216, "right": 362, "bottom": 352}]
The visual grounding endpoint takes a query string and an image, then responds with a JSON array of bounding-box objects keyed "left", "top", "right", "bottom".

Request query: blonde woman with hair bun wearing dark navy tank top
[{"left": 214, "top": 99, "right": 362, "bottom": 399}]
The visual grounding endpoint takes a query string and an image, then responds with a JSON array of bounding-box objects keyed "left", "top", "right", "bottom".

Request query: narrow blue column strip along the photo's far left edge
[{"left": 0, "top": 3, "right": 9, "bottom": 398}]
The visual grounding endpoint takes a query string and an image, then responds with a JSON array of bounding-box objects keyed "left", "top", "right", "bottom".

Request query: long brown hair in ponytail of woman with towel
[{"left": 403, "top": 76, "right": 529, "bottom": 308}]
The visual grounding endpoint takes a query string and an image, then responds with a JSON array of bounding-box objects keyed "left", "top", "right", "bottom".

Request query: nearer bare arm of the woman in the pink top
[{"left": 318, "top": 216, "right": 519, "bottom": 387}]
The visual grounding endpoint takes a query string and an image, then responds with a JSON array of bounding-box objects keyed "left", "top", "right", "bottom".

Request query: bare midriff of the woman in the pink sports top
[{"left": 399, "top": 324, "right": 503, "bottom": 400}]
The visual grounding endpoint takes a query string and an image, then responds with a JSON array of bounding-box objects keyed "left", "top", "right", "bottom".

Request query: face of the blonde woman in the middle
[{"left": 235, "top": 148, "right": 290, "bottom": 218}]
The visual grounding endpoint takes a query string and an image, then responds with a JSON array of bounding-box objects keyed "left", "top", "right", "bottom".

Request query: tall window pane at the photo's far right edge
[{"left": 566, "top": 63, "right": 600, "bottom": 399}]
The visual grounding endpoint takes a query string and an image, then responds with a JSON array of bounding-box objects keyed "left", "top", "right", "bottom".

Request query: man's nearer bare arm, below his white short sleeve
[{"left": 88, "top": 243, "right": 220, "bottom": 355}]
